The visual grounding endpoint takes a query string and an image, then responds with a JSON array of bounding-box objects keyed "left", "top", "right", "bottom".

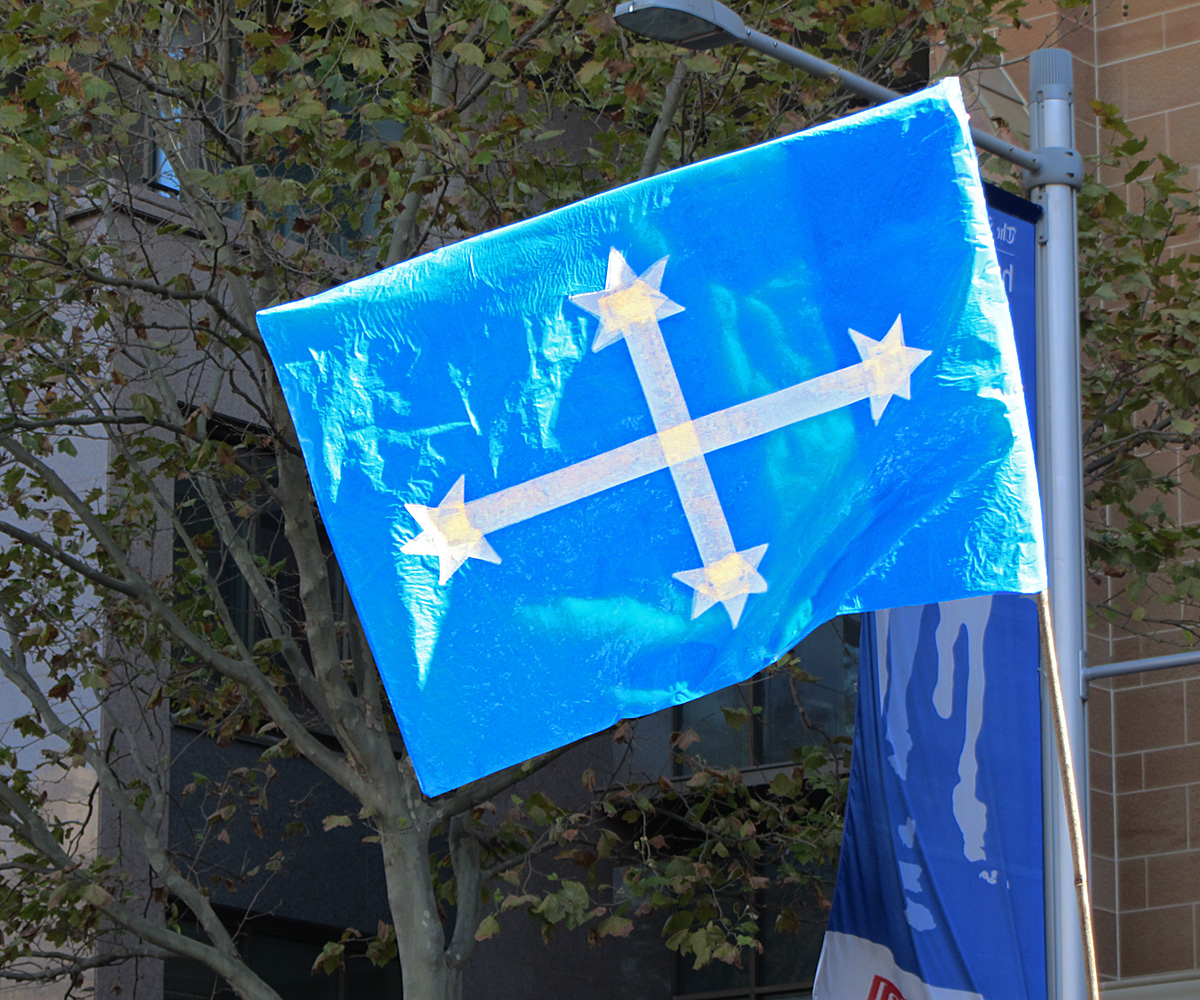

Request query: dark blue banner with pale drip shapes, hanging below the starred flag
[{"left": 814, "top": 594, "right": 1046, "bottom": 1000}]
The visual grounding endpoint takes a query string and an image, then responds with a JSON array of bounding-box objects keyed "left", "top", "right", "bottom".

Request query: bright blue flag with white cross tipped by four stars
[{"left": 259, "top": 82, "right": 1044, "bottom": 795}]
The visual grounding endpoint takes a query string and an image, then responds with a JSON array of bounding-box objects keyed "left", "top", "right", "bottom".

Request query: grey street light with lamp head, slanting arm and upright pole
[{"left": 613, "top": 0, "right": 1096, "bottom": 1000}]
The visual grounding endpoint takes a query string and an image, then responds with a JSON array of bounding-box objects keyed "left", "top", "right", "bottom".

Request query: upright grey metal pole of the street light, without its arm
[{"left": 1027, "top": 49, "right": 1087, "bottom": 1000}]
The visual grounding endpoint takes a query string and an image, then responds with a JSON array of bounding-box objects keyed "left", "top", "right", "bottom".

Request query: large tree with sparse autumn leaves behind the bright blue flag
[{"left": 0, "top": 0, "right": 1094, "bottom": 1000}]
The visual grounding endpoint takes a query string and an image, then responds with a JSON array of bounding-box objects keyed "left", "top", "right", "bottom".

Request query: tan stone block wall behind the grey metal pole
[{"left": 977, "top": 0, "right": 1200, "bottom": 995}]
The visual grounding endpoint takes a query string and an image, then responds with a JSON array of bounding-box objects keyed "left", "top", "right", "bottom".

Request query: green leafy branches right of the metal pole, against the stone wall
[{"left": 1080, "top": 103, "right": 1200, "bottom": 645}]
